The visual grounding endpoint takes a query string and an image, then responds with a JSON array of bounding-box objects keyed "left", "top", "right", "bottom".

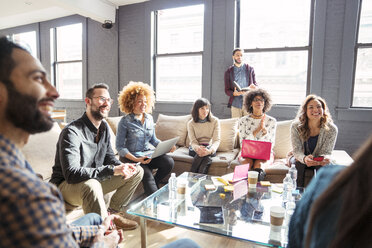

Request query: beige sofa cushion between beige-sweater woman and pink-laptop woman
[{"left": 217, "top": 118, "right": 239, "bottom": 152}]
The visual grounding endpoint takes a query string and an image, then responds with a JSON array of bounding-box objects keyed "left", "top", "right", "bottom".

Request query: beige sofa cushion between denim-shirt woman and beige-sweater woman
[{"left": 155, "top": 114, "right": 191, "bottom": 146}]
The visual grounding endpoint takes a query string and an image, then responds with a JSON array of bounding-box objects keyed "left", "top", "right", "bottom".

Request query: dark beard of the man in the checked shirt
[{"left": 4, "top": 80, "right": 54, "bottom": 134}]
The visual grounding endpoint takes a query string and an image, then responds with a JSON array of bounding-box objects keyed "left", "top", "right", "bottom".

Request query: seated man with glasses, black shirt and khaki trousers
[{"left": 50, "top": 84, "right": 143, "bottom": 230}]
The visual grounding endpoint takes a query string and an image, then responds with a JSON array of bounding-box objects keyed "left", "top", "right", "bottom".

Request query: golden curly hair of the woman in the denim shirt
[{"left": 118, "top": 81, "right": 155, "bottom": 114}]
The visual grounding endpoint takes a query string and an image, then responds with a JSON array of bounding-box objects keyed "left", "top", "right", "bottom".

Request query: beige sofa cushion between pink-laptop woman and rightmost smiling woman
[{"left": 273, "top": 120, "right": 292, "bottom": 159}]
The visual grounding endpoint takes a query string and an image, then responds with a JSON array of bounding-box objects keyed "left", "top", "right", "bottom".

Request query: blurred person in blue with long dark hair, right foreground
[{"left": 288, "top": 136, "right": 372, "bottom": 248}]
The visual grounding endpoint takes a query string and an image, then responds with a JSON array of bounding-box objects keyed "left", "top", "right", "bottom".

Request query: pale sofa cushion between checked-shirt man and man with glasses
[{"left": 22, "top": 122, "right": 61, "bottom": 180}]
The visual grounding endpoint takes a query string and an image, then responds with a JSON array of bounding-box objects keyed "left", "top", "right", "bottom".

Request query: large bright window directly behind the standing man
[{"left": 236, "top": 0, "right": 313, "bottom": 104}]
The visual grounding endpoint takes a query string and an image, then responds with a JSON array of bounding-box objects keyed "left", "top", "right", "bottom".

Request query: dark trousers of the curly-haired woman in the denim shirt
[{"left": 120, "top": 154, "right": 174, "bottom": 196}]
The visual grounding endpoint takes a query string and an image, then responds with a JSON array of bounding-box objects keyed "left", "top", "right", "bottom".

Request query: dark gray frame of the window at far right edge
[{"left": 336, "top": 0, "right": 372, "bottom": 122}]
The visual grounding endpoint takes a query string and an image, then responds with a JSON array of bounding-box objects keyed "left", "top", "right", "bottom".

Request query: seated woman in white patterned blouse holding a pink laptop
[{"left": 239, "top": 89, "right": 276, "bottom": 180}]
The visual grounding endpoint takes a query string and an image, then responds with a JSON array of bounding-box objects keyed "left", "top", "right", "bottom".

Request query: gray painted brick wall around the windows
[{"left": 0, "top": 0, "right": 372, "bottom": 154}]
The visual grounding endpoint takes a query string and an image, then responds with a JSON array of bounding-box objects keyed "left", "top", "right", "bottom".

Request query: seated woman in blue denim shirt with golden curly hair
[{"left": 116, "top": 82, "right": 175, "bottom": 196}]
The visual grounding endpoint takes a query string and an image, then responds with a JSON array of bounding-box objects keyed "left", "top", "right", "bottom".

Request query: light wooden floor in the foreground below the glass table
[{"left": 119, "top": 219, "right": 263, "bottom": 248}]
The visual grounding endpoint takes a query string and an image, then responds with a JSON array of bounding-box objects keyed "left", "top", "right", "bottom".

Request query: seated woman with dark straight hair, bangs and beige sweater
[{"left": 187, "top": 98, "right": 221, "bottom": 174}]
